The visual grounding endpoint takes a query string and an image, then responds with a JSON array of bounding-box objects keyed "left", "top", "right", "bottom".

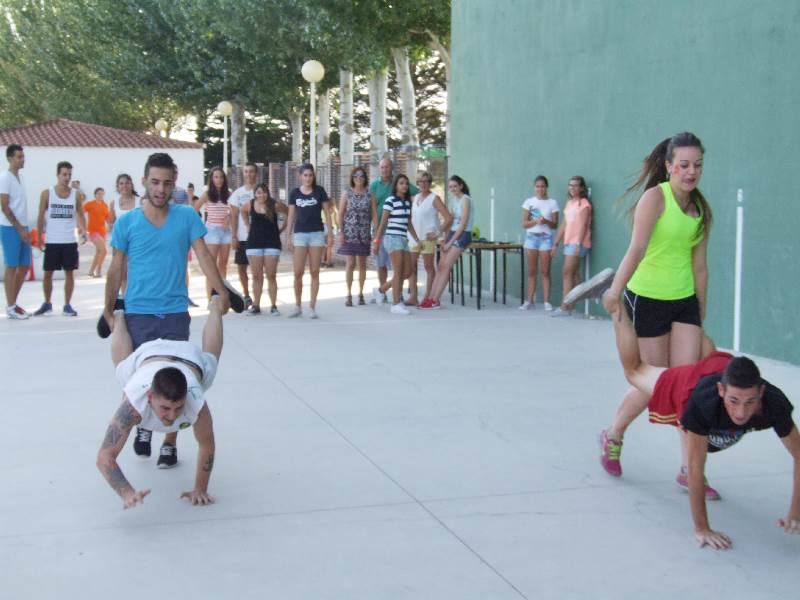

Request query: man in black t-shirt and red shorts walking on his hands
[{"left": 600, "top": 290, "right": 800, "bottom": 550}]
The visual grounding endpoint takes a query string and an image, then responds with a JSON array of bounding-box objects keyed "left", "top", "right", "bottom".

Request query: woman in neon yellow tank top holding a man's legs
[{"left": 600, "top": 132, "right": 719, "bottom": 500}]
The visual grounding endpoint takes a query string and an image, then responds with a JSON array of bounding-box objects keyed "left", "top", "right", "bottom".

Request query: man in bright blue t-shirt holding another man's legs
[{"left": 97, "top": 153, "right": 244, "bottom": 468}]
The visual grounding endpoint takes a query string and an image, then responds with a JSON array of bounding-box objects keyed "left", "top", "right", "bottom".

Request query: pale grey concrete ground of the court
[{"left": 0, "top": 246, "right": 800, "bottom": 600}]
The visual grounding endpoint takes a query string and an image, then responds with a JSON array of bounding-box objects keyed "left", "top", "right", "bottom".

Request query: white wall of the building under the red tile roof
[{"left": 12, "top": 146, "right": 204, "bottom": 227}]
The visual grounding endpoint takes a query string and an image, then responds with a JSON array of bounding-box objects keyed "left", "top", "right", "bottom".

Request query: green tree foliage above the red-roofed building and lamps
[{"left": 0, "top": 0, "right": 450, "bottom": 149}]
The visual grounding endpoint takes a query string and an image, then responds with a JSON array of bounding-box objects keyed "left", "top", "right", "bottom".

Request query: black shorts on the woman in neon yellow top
[{"left": 623, "top": 289, "right": 702, "bottom": 337}]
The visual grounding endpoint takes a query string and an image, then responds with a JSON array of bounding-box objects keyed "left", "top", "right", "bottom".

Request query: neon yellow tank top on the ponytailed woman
[{"left": 628, "top": 181, "right": 703, "bottom": 300}]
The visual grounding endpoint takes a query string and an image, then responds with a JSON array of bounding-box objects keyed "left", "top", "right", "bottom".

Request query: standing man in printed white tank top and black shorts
[{"left": 33, "top": 161, "right": 86, "bottom": 317}]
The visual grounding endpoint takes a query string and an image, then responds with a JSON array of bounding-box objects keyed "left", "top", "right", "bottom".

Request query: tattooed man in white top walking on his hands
[{"left": 97, "top": 295, "right": 227, "bottom": 508}]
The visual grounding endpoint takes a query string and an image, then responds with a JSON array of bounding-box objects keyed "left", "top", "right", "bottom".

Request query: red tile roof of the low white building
[{"left": 0, "top": 119, "right": 203, "bottom": 148}]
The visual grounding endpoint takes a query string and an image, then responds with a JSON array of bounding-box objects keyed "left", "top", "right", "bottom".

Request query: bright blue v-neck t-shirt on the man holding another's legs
[{"left": 111, "top": 204, "right": 206, "bottom": 315}]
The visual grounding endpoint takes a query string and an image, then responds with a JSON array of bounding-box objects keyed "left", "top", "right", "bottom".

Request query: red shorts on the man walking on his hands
[{"left": 647, "top": 352, "right": 733, "bottom": 426}]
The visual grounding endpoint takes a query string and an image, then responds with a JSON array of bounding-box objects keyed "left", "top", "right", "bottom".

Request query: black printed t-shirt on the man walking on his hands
[{"left": 681, "top": 373, "right": 794, "bottom": 452}]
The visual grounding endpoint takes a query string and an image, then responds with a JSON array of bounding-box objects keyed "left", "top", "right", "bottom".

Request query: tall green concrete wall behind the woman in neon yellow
[{"left": 449, "top": 0, "right": 800, "bottom": 363}]
